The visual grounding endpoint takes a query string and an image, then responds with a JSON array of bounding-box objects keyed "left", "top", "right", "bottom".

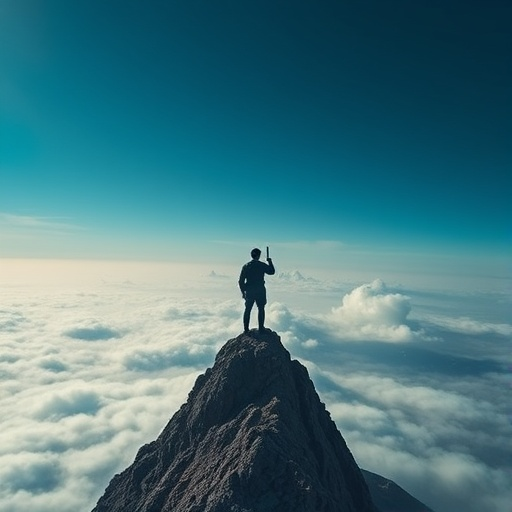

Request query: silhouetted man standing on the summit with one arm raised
[{"left": 238, "top": 249, "right": 276, "bottom": 332}]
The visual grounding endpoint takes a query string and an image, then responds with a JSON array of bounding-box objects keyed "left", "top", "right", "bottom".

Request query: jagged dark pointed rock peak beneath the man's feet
[{"left": 93, "top": 331, "right": 376, "bottom": 512}]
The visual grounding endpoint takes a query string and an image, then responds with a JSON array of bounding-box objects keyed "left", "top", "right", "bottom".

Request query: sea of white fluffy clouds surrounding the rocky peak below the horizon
[{"left": 0, "top": 264, "right": 512, "bottom": 512}]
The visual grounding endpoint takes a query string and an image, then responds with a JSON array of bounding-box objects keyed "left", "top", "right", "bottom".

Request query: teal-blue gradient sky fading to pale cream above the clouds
[{"left": 0, "top": 0, "right": 512, "bottom": 268}]
